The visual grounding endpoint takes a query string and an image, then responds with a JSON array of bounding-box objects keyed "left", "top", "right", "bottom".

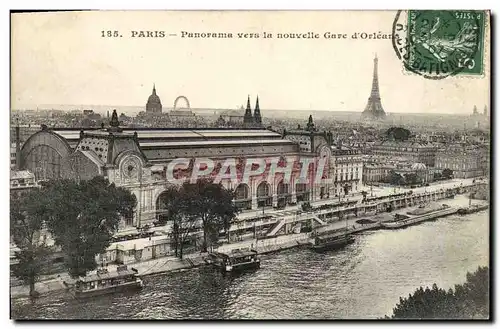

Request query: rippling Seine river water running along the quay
[{"left": 12, "top": 211, "right": 489, "bottom": 319}]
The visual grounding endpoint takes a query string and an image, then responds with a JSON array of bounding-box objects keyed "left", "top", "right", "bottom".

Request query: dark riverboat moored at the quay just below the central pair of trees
[{"left": 206, "top": 248, "right": 260, "bottom": 273}]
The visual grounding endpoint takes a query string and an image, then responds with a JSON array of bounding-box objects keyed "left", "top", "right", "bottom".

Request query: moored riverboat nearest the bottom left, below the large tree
[{"left": 74, "top": 265, "right": 143, "bottom": 298}]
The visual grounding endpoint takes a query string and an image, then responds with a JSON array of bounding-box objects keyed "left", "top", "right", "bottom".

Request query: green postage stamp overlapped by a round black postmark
[{"left": 392, "top": 10, "right": 487, "bottom": 79}]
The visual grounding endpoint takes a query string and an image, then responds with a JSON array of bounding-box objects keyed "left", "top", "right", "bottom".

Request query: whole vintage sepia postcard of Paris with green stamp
[{"left": 10, "top": 10, "right": 491, "bottom": 320}]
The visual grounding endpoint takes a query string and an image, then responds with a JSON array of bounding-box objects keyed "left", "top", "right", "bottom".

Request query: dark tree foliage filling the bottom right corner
[{"left": 392, "top": 267, "right": 490, "bottom": 319}]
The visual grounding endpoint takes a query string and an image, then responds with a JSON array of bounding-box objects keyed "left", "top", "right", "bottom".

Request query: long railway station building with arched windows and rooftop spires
[{"left": 19, "top": 112, "right": 346, "bottom": 227}]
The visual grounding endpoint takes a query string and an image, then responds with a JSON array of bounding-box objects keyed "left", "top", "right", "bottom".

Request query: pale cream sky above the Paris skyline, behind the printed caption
[{"left": 11, "top": 11, "right": 490, "bottom": 114}]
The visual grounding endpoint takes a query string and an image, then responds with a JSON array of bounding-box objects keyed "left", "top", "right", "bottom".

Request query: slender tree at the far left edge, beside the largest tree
[{"left": 10, "top": 190, "right": 51, "bottom": 297}]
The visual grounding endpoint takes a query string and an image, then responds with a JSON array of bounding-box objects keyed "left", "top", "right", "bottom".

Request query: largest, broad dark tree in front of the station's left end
[{"left": 42, "top": 176, "right": 137, "bottom": 278}]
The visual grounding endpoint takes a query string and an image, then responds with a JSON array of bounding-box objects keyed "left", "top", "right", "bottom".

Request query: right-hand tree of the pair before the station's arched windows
[{"left": 182, "top": 179, "right": 239, "bottom": 251}]
